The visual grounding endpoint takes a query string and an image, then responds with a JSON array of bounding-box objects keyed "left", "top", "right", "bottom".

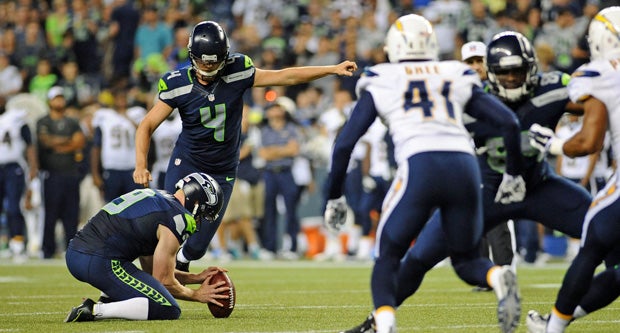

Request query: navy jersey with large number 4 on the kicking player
[{"left": 159, "top": 53, "right": 256, "bottom": 173}]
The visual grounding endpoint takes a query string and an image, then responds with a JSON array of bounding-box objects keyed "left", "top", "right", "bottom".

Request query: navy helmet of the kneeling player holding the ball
[{"left": 175, "top": 172, "right": 224, "bottom": 222}]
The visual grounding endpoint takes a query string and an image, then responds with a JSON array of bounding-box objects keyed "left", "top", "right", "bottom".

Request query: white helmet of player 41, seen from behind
[{"left": 384, "top": 14, "right": 439, "bottom": 63}]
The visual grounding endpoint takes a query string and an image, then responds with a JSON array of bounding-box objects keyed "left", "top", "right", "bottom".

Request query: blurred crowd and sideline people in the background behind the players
[{"left": 0, "top": 0, "right": 620, "bottom": 260}]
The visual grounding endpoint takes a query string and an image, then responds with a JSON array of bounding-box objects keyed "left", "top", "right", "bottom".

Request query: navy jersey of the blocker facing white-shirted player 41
[{"left": 472, "top": 72, "right": 570, "bottom": 184}]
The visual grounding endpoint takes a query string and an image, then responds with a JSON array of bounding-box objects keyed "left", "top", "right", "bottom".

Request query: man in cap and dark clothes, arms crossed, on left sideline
[{"left": 37, "top": 86, "right": 85, "bottom": 259}]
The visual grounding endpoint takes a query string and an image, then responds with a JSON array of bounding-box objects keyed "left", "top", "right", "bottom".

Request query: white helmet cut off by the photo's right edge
[{"left": 588, "top": 6, "right": 620, "bottom": 60}]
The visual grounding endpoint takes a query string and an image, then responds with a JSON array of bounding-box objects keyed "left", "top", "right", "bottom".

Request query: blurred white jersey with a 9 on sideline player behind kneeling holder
[{"left": 93, "top": 107, "right": 146, "bottom": 170}]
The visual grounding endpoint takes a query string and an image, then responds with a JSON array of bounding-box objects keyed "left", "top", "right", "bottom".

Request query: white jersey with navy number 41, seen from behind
[{"left": 357, "top": 61, "right": 482, "bottom": 163}]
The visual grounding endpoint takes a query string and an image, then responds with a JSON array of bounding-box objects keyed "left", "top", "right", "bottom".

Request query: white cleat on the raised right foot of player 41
[{"left": 492, "top": 266, "right": 521, "bottom": 333}]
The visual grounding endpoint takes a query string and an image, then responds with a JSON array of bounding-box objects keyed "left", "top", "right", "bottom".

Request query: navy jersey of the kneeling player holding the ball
[{"left": 70, "top": 188, "right": 196, "bottom": 261}]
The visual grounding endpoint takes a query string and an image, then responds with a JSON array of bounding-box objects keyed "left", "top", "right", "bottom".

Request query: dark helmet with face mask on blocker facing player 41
[{"left": 487, "top": 31, "right": 538, "bottom": 102}]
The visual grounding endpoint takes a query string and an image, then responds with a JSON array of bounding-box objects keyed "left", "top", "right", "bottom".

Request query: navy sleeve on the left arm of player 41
[{"left": 327, "top": 91, "right": 377, "bottom": 199}]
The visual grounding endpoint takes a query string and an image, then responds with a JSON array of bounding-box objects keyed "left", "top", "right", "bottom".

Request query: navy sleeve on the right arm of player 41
[{"left": 465, "top": 86, "right": 521, "bottom": 175}]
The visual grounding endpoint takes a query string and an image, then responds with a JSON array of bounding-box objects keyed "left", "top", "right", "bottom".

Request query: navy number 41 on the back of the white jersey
[{"left": 405, "top": 80, "right": 455, "bottom": 119}]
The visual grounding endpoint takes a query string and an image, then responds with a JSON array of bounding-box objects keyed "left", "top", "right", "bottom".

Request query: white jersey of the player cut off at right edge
[{"left": 568, "top": 59, "right": 620, "bottom": 184}]
